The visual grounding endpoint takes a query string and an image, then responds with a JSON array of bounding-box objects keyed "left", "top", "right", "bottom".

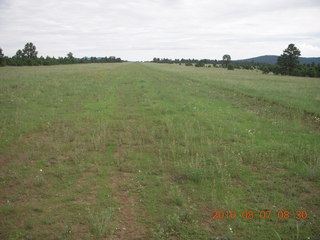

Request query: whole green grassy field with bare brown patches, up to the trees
[{"left": 0, "top": 63, "right": 320, "bottom": 240}]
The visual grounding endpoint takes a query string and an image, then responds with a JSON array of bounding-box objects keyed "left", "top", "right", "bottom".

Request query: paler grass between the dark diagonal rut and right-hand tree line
[{"left": 150, "top": 64, "right": 320, "bottom": 114}]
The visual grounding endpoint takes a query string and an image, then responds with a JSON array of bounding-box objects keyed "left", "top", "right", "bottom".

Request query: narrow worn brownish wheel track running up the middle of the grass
[{"left": 111, "top": 79, "right": 146, "bottom": 240}]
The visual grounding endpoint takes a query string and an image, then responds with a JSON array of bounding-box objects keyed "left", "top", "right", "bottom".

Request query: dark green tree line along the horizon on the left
[{"left": 0, "top": 42, "right": 124, "bottom": 66}]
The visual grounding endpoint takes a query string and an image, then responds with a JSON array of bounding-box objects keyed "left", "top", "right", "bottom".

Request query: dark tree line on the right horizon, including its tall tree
[{"left": 152, "top": 43, "right": 320, "bottom": 77}]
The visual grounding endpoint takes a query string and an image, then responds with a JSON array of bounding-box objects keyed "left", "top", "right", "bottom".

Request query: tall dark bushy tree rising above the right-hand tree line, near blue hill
[{"left": 278, "top": 43, "right": 301, "bottom": 75}]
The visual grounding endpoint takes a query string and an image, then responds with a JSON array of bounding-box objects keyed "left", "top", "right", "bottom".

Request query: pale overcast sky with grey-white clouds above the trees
[{"left": 0, "top": 0, "right": 320, "bottom": 60}]
